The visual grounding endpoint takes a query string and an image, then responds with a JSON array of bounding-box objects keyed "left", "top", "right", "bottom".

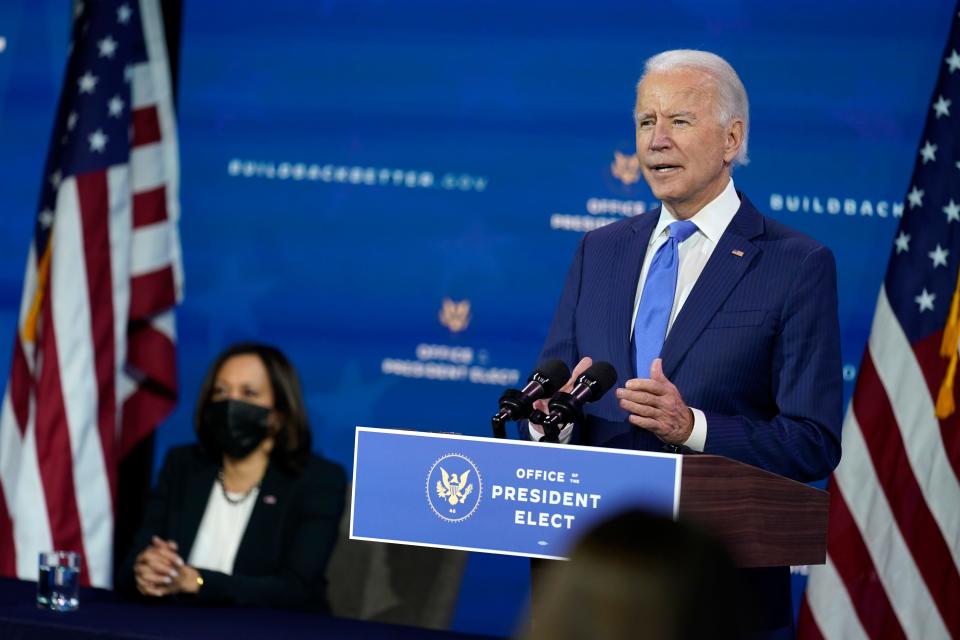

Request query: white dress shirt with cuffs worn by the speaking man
[{"left": 530, "top": 178, "right": 740, "bottom": 451}]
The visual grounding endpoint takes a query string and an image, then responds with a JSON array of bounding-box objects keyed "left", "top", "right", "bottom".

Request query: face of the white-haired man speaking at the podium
[{"left": 634, "top": 69, "right": 743, "bottom": 219}]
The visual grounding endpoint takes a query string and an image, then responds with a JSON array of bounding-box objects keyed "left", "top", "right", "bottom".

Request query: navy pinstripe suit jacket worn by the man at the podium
[{"left": 536, "top": 194, "right": 843, "bottom": 481}]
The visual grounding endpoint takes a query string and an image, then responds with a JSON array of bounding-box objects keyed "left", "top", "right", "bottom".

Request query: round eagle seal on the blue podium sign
[{"left": 427, "top": 453, "right": 483, "bottom": 522}]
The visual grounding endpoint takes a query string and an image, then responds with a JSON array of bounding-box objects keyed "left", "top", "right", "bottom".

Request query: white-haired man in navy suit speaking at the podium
[{"left": 522, "top": 50, "right": 842, "bottom": 637}]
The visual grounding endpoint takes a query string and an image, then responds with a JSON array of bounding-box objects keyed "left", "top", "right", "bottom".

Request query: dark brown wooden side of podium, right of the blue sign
[{"left": 679, "top": 455, "right": 829, "bottom": 567}]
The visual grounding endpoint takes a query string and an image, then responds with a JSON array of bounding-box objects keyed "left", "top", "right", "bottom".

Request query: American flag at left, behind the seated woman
[{"left": 0, "top": 0, "right": 183, "bottom": 587}]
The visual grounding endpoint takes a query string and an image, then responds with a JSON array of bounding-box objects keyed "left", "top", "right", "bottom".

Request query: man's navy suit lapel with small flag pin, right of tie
[{"left": 661, "top": 194, "right": 763, "bottom": 378}]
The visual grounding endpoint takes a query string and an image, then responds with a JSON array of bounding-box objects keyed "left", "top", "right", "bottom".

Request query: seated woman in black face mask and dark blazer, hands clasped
[{"left": 118, "top": 343, "right": 346, "bottom": 612}]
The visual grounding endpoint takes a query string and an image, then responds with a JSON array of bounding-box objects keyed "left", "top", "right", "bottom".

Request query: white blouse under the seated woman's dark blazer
[{"left": 187, "top": 480, "right": 260, "bottom": 575}]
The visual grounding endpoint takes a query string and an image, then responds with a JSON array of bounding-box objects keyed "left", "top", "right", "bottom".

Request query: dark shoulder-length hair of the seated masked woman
[{"left": 193, "top": 342, "right": 311, "bottom": 474}]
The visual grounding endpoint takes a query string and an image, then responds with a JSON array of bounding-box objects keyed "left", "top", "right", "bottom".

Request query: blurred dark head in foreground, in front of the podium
[{"left": 526, "top": 511, "right": 744, "bottom": 640}]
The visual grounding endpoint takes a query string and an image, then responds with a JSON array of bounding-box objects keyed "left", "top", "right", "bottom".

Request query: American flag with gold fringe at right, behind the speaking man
[{"left": 799, "top": 7, "right": 960, "bottom": 638}]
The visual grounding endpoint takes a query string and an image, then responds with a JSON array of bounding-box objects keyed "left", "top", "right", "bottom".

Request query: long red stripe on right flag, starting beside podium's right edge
[{"left": 827, "top": 486, "right": 906, "bottom": 639}]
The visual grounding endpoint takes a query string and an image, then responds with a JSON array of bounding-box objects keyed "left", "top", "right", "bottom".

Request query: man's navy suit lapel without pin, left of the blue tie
[{"left": 608, "top": 212, "right": 660, "bottom": 384}]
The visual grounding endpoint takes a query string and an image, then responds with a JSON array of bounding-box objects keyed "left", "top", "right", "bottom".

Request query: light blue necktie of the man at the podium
[{"left": 633, "top": 220, "right": 697, "bottom": 378}]
